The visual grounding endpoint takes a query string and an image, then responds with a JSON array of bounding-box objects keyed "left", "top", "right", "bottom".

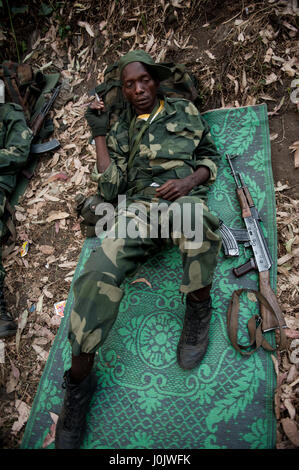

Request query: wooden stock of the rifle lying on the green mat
[{"left": 259, "top": 271, "right": 286, "bottom": 332}]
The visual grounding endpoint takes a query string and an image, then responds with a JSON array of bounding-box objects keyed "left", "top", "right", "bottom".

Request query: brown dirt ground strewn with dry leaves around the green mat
[{"left": 0, "top": 0, "right": 299, "bottom": 449}]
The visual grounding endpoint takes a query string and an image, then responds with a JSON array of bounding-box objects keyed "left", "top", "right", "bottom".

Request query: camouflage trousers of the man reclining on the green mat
[{"left": 68, "top": 196, "right": 221, "bottom": 356}]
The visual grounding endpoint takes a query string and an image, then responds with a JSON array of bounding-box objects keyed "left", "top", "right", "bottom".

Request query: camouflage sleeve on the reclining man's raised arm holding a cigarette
[{"left": 92, "top": 121, "right": 129, "bottom": 201}]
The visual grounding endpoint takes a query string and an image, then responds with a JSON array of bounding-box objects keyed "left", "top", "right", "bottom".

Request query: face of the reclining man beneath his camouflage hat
[{"left": 122, "top": 62, "right": 159, "bottom": 114}]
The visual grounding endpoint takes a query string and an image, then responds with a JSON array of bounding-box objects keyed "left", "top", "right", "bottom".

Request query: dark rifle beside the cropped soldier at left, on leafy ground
[{"left": 30, "top": 85, "right": 61, "bottom": 154}]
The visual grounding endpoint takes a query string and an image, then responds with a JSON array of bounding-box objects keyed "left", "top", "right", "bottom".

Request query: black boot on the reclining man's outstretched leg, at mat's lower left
[{"left": 55, "top": 370, "right": 96, "bottom": 449}]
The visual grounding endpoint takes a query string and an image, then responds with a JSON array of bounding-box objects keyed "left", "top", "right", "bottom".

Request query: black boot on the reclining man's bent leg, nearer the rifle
[{"left": 177, "top": 297, "right": 212, "bottom": 369}]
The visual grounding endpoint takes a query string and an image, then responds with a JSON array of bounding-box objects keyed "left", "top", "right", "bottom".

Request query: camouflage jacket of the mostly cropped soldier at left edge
[{"left": 0, "top": 103, "right": 32, "bottom": 193}]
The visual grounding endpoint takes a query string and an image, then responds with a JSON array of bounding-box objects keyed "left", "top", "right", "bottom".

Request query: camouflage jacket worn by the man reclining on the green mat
[{"left": 92, "top": 98, "right": 220, "bottom": 201}]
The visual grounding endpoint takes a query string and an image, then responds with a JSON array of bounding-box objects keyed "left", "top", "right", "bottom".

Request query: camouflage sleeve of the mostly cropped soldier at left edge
[{"left": 0, "top": 104, "right": 33, "bottom": 174}]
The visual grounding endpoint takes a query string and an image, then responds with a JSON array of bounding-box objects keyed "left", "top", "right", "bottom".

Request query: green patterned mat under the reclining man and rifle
[{"left": 21, "top": 105, "right": 277, "bottom": 449}]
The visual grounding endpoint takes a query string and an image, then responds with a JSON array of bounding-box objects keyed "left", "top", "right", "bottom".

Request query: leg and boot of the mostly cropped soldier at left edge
[{"left": 0, "top": 190, "right": 17, "bottom": 338}]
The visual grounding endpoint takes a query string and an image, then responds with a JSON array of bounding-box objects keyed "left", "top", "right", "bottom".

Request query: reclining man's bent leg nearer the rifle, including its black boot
[{"left": 173, "top": 197, "right": 221, "bottom": 369}]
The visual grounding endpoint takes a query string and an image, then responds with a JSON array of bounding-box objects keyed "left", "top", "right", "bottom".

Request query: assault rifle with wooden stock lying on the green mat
[{"left": 219, "top": 154, "right": 286, "bottom": 333}]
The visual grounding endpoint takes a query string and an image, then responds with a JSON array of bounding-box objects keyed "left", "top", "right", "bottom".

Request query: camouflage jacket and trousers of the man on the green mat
[{"left": 69, "top": 98, "right": 221, "bottom": 355}]
